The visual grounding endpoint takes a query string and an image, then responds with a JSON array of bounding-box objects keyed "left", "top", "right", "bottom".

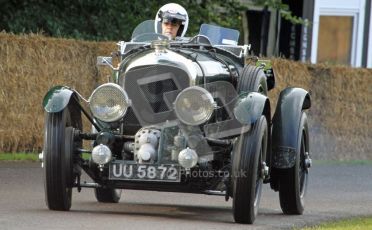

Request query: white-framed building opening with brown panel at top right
[{"left": 311, "top": 0, "right": 366, "bottom": 67}]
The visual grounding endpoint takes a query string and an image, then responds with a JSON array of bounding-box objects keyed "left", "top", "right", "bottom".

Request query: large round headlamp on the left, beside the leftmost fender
[{"left": 89, "top": 83, "right": 130, "bottom": 122}]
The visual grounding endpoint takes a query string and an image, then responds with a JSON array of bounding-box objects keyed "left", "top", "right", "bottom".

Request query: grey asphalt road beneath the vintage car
[{"left": 0, "top": 162, "right": 372, "bottom": 230}]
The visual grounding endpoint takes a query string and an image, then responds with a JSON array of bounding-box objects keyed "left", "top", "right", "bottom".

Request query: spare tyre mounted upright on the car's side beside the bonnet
[{"left": 237, "top": 65, "right": 267, "bottom": 95}]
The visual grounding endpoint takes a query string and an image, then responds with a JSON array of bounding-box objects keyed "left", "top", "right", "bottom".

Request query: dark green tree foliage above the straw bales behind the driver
[{"left": 0, "top": 0, "right": 302, "bottom": 41}]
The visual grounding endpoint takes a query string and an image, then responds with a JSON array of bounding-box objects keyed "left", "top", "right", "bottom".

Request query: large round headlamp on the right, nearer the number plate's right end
[{"left": 174, "top": 86, "right": 216, "bottom": 125}]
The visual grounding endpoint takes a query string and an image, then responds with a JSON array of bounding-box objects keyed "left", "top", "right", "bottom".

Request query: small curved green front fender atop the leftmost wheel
[{"left": 43, "top": 86, "right": 74, "bottom": 113}]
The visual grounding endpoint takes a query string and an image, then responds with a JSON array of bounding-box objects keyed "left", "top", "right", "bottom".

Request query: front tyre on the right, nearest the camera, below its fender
[{"left": 232, "top": 116, "right": 268, "bottom": 224}]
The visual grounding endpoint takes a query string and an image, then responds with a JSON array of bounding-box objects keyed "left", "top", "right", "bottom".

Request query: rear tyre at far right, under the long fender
[{"left": 279, "top": 112, "right": 310, "bottom": 215}]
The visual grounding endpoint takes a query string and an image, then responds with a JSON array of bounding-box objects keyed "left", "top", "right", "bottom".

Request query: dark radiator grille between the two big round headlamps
[{"left": 122, "top": 65, "right": 190, "bottom": 127}]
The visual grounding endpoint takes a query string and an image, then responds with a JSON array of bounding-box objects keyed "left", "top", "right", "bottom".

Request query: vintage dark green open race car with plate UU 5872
[{"left": 40, "top": 21, "right": 311, "bottom": 223}]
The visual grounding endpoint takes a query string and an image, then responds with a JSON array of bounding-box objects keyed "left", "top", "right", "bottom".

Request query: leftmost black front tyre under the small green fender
[{"left": 43, "top": 108, "right": 74, "bottom": 211}]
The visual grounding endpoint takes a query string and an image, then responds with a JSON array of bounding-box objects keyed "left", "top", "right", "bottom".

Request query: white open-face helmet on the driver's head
[{"left": 155, "top": 3, "right": 189, "bottom": 37}]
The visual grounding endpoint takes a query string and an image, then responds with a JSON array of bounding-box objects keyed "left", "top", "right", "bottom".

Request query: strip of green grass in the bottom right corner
[{"left": 301, "top": 217, "right": 372, "bottom": 230}]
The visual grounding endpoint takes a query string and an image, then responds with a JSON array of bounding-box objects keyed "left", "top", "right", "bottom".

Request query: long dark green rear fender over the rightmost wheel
[{"left": 272, "top": 88, "right": 311, "bottom": 169}]
